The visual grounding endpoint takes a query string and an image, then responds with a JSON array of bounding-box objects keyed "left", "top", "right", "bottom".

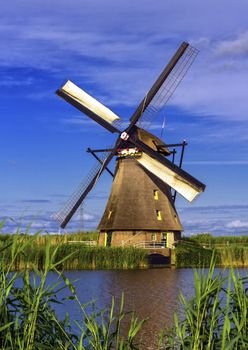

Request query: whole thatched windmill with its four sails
[{"left": 56, "top": 42, "right": 205, "bottom": 246}]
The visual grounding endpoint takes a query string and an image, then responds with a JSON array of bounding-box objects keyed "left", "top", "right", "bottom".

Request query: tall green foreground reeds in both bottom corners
[{"left": 0, "top": 223, "right": 248, "bottom": 350}]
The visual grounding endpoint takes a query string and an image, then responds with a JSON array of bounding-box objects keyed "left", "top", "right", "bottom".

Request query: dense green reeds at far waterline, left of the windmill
[{"left": 1, "top": 235, "right": 148, "bottom": 270}]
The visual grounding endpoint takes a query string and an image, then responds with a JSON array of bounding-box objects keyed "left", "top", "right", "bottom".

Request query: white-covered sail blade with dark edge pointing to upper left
[{"left": 56, "top": 80, "right": 120, "bottom": 132}]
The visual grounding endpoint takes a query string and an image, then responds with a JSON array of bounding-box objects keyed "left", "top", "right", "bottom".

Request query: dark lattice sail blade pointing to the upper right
[{"left": 130, "top": 42, "right": 198, "bottom": 127}]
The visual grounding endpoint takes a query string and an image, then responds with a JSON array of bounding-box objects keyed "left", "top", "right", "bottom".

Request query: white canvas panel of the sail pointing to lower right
[{"left": 137, "top": 152, "right": 203, "bottom": 202}]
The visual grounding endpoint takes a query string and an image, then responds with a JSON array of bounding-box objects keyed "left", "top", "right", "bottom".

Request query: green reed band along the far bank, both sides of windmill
[{"left": 0, "top": 232, "right": 248, "bottom": 270}]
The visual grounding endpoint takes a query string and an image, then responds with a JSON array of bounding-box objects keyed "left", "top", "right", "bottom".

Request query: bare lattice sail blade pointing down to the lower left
[{"left": 54, "top": 150, "right": 115, "bottom": 228}]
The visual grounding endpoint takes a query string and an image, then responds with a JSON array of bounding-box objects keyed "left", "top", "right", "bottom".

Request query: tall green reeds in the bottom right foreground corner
[{"left": 160, "top": 259, "right": 248, "bottom": 350}]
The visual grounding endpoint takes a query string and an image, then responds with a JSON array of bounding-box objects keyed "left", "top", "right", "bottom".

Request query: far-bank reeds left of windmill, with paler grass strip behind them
[{"left": 0, "top": 232, "right": 148, "bottom": 270}]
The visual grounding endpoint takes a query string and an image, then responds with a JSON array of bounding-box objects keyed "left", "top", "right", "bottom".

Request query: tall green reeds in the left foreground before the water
[{"left": 0, "top": 223, "right": 144, "bottom": 350}]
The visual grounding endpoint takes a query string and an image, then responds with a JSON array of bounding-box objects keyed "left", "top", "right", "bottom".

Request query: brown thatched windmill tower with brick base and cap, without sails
[{"left": 98, "top": 129, "right": 182, "bottom": 246}]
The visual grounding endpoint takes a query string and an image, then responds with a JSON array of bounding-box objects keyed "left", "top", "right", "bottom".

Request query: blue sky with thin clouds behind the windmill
[{"left": 0, "top": 0, "right": 248, "bottom": 235}]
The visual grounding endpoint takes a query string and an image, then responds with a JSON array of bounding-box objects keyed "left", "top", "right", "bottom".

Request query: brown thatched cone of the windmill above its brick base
[{"left": 98, "top": 158, "right": 182, "bottom": 231}]
